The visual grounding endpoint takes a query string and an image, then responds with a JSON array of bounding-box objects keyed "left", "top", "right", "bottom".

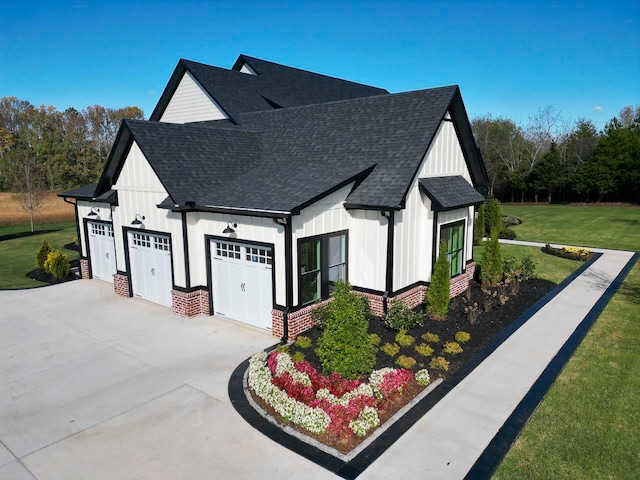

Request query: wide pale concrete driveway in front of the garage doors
[{"left": 0, "top": 280, "right": 335, "bottom": 480}]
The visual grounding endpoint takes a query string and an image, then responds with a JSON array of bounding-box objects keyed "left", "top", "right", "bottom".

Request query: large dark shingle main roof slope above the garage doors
[{"left": 121, "top": 86, "right": 459, "bottom": 212}]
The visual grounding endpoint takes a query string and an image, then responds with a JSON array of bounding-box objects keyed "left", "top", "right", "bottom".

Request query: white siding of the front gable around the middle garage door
[{"left": 113, "top": 142, "right": 186, "bottom": 287}]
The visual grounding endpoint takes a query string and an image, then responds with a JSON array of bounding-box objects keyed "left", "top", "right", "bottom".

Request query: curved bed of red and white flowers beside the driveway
[{"left": 248, "top": 351, "right": 428, "bottom": 436}]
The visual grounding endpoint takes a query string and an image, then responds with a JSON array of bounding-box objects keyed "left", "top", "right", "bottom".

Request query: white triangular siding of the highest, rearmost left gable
[{"left": 160, "top": 72, "right": 227, "bottom": 123}]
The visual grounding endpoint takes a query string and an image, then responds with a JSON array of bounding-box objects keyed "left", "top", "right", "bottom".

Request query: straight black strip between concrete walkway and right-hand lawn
[{"left": 464, "top": 252, "right": 640, "bottom": 480}]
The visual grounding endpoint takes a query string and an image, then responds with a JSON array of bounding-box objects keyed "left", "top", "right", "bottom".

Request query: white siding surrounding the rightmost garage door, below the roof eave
[{"left": 187, "top": 212, "right": 286, "bottom": 305}]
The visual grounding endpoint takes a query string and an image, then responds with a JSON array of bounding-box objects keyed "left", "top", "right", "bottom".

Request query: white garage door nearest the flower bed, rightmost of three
[{"left": 211, "top": 240, "right": 273, "bottom": 329}]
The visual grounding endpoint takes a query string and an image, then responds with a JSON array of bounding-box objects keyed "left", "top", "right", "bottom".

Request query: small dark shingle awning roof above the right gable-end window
[{"left": 418, "top": 175, "right": 484, "bottom": 212}]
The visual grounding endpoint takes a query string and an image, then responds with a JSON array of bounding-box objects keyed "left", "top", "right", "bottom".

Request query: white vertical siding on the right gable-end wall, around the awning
[{"left": 393, "top": 114, "right": 473, "bottom": 291}]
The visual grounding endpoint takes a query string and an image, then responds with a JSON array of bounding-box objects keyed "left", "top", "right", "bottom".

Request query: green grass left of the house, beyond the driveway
[{"left": 0, "top": 222, "right": 78, "bottom": 288}]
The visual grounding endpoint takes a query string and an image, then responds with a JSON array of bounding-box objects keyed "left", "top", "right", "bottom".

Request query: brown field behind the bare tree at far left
[{"left": 0, "top": 192, "right": 75, "bottom": 227}]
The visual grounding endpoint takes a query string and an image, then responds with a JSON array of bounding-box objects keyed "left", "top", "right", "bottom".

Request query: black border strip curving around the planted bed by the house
[{"left": 228, "top": 253, "right": 604, "bottom": 480}]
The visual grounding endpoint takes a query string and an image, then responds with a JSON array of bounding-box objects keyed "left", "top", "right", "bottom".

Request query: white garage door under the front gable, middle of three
[{"left": 129, "top": 232, "right": 173, "bottom": 307}]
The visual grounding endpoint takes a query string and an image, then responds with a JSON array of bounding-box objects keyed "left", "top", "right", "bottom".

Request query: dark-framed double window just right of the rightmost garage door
[{"left": 298, "top": 232, "right": 347, "bottom": 305}]
